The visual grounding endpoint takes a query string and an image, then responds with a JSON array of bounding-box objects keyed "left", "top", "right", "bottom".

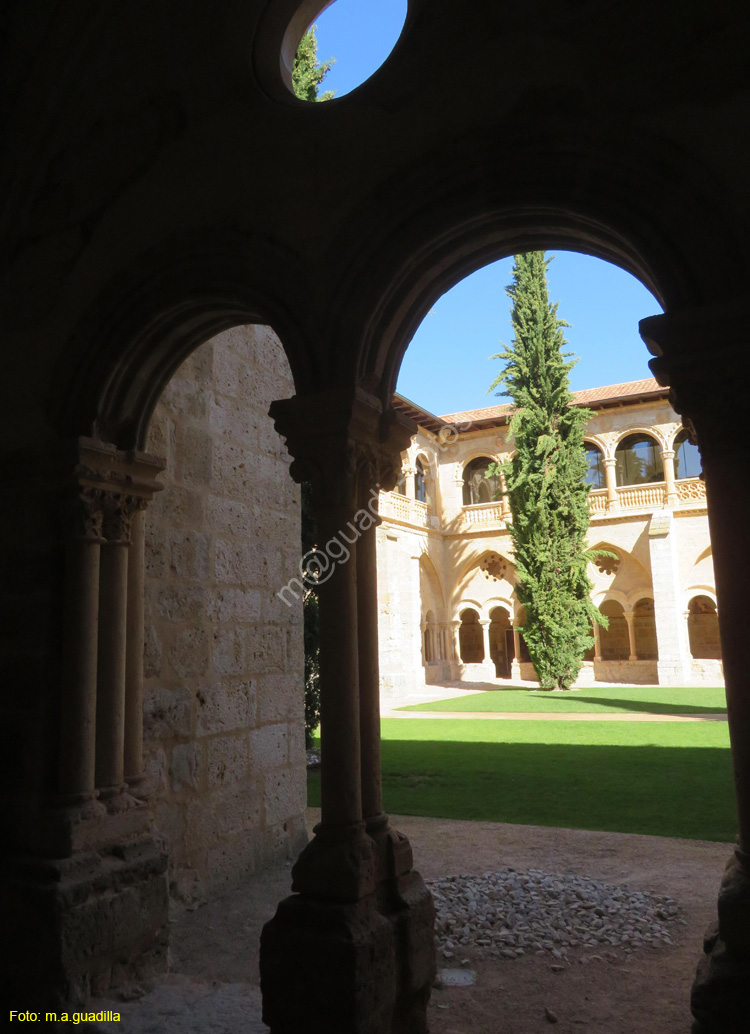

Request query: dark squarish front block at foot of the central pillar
[{"left": 261, "top": 894, "right": 396, "bottom": 1034}]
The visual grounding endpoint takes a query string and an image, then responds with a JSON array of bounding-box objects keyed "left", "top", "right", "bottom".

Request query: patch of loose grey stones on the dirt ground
[{"left": 428, "top": 869, "right": 685, "bottom": 962}]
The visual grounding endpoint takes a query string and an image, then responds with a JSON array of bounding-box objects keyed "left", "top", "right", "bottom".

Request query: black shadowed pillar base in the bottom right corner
[{"left": 690, "top": 851, "right": 750, "bottom": 1034}]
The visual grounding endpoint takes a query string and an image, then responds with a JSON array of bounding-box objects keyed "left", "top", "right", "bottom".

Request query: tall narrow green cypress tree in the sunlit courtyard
[{"left": 488, "top": 251, "right": 606, "bottom": 690}]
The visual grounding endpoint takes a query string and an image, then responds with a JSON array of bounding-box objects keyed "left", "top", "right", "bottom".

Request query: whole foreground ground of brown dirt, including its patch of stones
[{"left": 86, "top": 809, "right": 731, "bottom": 1034}]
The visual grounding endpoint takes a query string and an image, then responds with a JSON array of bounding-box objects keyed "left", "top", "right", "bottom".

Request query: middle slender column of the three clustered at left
[{"left": 96, "top": 493, "right": 131, "bottom": 811}]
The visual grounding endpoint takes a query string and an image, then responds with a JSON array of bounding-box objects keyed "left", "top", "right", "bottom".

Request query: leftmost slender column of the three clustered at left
[{"left": 57, "top": 489, "right": 103, "bottom": 816}]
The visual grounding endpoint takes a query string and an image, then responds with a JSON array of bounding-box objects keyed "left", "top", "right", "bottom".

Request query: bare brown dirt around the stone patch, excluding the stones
[{"left": 159, "top": 809, "right": 731, "bottom": 1034}]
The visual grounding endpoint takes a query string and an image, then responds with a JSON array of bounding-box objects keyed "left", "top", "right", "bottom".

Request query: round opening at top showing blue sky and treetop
[{"left": 292, "top": 0, "right": 408, "bottom": 101}]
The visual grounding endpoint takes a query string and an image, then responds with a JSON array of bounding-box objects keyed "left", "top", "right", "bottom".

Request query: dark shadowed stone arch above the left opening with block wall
[{"left": 52, "top": 231, "right": 312, "bottom": 449}]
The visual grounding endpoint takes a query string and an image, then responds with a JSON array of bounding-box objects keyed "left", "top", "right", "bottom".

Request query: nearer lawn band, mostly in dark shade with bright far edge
[{"left": 308, "top": 719, "right": 737, "bottom": 841}]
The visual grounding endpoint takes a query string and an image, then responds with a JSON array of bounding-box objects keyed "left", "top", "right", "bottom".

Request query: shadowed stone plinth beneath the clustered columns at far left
[{"left": 0, "top": 835, "right": 169, "bottom": 1010}]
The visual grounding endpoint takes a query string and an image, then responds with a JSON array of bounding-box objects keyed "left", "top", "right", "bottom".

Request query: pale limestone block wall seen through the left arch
[{"left": 144, "top": 327, "right": 306, "bottom": 899}]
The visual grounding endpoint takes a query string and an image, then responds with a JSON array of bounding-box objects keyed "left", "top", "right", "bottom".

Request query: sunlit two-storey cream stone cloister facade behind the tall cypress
[{"left": 378, "top": 379, "right": 723, "bottom": 701}]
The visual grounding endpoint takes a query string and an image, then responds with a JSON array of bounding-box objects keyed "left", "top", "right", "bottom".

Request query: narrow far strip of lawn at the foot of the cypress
[{"left": 399, "top": 686, "right": 726, "bottom": 714}]
